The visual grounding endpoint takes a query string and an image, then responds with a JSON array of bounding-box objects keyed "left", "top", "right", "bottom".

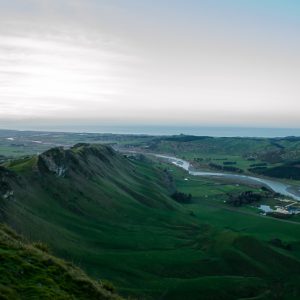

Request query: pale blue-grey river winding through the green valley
[{"left": 152, "top": 154, "right": 300, "bottom": 201}]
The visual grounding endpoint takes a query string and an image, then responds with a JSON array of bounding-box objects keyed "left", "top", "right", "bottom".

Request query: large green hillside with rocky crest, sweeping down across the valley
[{"left": 0, "top": 144, "right": 300, "bottom": 300}]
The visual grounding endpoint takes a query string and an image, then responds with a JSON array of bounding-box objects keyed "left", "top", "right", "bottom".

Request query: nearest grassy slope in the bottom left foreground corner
[{"left": 0, "top": 224, "right": 121, "bottom": 300}]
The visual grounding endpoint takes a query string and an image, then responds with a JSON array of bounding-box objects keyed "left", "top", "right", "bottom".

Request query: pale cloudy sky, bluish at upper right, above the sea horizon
[{"left": 0, "top": 0, "right": 300, "bottom": 129}]
